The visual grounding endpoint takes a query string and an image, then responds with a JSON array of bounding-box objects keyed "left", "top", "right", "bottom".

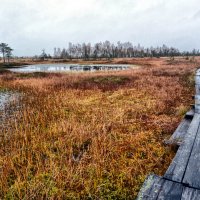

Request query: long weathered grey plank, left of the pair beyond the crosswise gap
[{"left": 164, "top": 113, "right": 200, "bottom": 182}]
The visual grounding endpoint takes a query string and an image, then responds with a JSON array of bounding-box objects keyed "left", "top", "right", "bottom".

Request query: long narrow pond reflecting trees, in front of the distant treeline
[{"left": 10, "top": 64, "right": 129, "bottom": 73}]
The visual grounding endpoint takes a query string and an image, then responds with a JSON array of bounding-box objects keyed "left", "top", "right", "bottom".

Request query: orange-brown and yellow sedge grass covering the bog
[{"left": 0, "top": 59, "right": 198, "bottom": 199}]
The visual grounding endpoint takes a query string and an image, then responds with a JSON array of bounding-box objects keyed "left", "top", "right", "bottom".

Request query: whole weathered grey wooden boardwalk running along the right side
[{"left": 137, "top": 70, "right": 200, "bottom": 200}]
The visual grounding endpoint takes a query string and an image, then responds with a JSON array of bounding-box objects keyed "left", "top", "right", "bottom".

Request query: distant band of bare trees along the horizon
[{"left": 53, "top": 41, "right": 200, "bottom": 60}]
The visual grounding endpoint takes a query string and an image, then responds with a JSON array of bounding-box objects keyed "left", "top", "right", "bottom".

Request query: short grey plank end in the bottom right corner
[{"left": 181, "top": 187, "right": 200, "bottom": 200}]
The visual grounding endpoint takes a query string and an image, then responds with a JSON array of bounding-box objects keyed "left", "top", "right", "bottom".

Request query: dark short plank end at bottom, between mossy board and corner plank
[{"left": 157, "top": 180, "right": 183, "bottom": 200}]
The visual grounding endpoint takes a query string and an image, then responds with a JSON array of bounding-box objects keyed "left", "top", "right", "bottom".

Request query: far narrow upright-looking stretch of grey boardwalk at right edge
[{"left": 195, "top": 69, "right": 200, "bottom": 114}]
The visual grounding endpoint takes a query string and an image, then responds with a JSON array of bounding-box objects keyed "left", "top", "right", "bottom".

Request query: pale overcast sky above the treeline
[{"left": 0, "top": 0, "right": 200, "bottom": 56}]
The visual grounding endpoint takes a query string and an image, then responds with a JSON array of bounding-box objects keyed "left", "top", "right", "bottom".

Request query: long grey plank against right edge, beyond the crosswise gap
[{"left": 183, "top": 119, "right": 200, "bottom": 189}]
